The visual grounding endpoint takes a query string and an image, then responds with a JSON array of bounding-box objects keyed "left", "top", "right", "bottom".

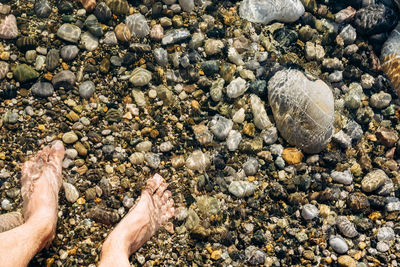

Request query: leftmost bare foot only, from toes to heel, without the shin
[{"left": 21, "top": 141, "right": 65, "bottom": 249}]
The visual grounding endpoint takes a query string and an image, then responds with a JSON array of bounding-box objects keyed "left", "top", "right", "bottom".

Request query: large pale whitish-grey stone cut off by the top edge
[{"left": 239, "top": 0, "right": 305, "bottom": 24}]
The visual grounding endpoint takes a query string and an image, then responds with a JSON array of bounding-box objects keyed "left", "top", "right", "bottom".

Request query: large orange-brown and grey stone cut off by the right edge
[{"left": 381, "top": 23, "right": 400, "bottom": 96}]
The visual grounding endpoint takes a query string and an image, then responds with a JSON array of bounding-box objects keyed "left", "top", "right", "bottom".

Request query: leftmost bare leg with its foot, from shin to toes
[{"left": 0, "top": 141, "right": 64, "bottom": 267}]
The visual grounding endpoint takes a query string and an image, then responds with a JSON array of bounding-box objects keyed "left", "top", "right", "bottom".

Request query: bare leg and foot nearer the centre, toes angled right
[{"left": 99, "top": 174, "right": 174, "bottom": 267}]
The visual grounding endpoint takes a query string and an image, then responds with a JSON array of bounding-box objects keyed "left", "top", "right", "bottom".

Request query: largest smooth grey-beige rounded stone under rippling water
[{"left": 268, "top": 70, "right": 334, "bottom": 153}]
